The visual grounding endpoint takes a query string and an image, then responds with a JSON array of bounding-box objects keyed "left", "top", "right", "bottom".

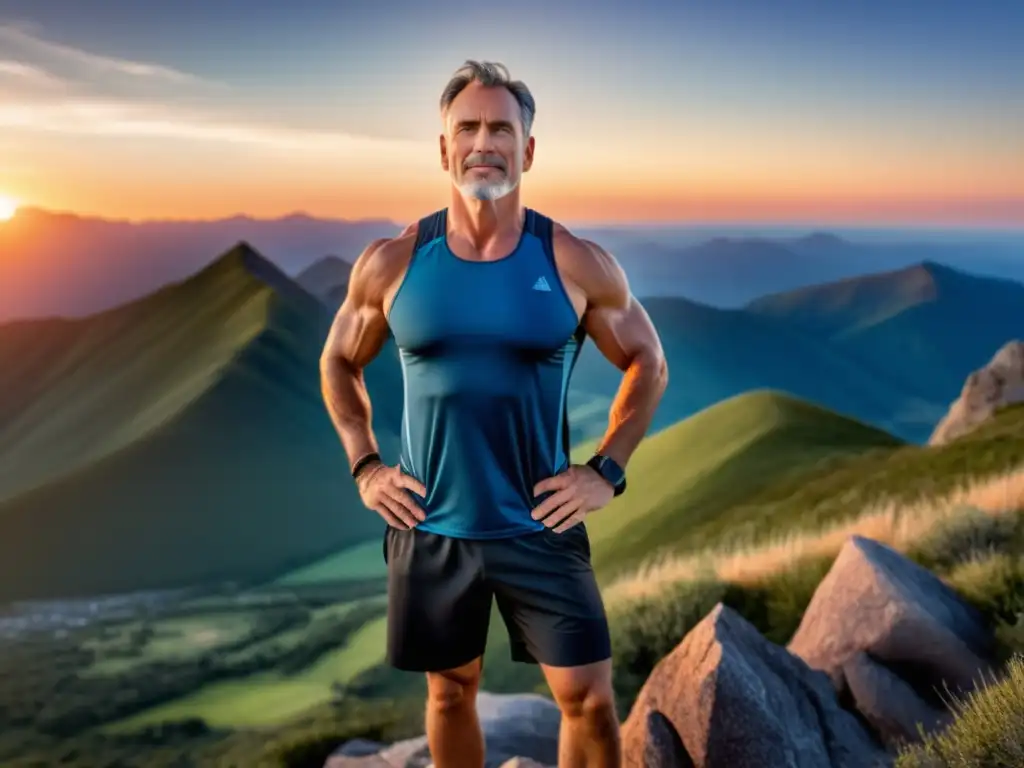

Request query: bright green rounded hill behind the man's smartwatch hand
[{"left": 573, "top": 391, "right": 902, "bottom": 581}]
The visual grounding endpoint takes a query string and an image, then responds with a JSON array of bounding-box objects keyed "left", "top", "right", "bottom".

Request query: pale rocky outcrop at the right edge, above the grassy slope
[{"left": 928, "top": 341, "right": 1024, "bottom": 445}]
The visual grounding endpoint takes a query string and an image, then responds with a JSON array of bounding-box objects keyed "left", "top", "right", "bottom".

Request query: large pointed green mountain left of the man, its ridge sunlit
[{"left": 0, "top": 243, "right": 395, "bottom": 599}]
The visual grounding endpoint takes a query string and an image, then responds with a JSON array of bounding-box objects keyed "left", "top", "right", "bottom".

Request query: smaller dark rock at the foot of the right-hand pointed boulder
[{"left": 843, "top": 652, "right": 952, "bottom": 749}]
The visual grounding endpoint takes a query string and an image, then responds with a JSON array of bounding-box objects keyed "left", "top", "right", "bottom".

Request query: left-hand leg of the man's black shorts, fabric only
[{"left": 384, "top": 526, "right": 492, "bottom": 672}]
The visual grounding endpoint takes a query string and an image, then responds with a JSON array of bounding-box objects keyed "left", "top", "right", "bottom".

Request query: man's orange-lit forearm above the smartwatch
[{"left": 597, "top": 352, "right": 669, "bottom": 467}]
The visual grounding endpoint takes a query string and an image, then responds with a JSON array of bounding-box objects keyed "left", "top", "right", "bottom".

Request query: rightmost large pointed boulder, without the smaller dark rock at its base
[{"left": 788, "top": 536, "right": 994, "bottom": 705}]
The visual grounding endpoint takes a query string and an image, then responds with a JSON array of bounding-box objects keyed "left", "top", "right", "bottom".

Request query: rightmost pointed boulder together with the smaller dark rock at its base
[{"left": 788, "top": 536, "right": 994, "bottom": 741}]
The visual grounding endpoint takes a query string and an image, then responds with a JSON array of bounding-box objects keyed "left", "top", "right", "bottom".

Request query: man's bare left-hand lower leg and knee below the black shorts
[{"left": 426, "top": 658, "right": 483, "bottom": 768}]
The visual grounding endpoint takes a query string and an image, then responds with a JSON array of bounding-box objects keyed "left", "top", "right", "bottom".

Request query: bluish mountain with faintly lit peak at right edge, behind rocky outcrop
[{"left": 748, "top": 262, "right": 1024, "bottom": 404}]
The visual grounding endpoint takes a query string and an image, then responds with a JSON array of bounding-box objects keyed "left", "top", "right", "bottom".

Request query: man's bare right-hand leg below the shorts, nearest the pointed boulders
[{"left": 541, "top": 658, "right": 622, "bottom": 768}]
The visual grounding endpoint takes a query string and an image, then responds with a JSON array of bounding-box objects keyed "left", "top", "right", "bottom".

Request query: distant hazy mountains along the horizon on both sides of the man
[{"left": 0, "top": 209, "right": 1024, "bottom": 322}]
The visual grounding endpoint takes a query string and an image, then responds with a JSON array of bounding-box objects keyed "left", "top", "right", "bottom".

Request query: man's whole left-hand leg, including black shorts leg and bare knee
[{"left": 384, "top": 528, "right": 492, "bottom": 768}]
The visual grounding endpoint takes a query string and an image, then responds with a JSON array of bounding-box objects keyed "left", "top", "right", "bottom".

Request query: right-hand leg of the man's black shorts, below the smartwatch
[{"left": 482, "top": 523, "right": 611, "bottom": 667}]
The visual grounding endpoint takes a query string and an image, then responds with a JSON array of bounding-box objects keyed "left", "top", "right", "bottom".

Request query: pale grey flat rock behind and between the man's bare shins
[{"left": 325, "top": 691, "right": 561, "bottom": 768}]
